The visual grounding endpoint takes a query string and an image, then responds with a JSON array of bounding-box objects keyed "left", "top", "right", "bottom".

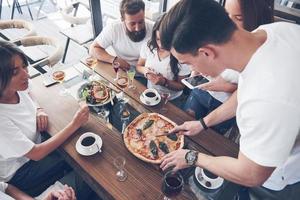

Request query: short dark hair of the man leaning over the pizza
[{"left": 160, "top": 0, "right": 236, "bottom": 54}]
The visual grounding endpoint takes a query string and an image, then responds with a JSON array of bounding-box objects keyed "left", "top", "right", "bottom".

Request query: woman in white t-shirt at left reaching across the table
[{"left": 0, "top": 41, "right": 89, "bottom": 196}]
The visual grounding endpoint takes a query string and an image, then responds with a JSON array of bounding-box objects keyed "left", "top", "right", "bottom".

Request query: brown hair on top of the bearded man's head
[{"left": 120, "top": 0, "right": 145, "bottom": 19}]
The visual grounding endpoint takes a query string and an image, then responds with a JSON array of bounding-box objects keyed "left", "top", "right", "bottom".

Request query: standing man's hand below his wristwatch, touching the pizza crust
[{"left": 160, "top": 149, "right": 189, "bottom": 172}]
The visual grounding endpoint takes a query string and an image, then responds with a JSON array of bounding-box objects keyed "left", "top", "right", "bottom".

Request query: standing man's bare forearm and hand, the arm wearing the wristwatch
[{"left": 160, "top": 149, "right": 275, "bottom": 187}]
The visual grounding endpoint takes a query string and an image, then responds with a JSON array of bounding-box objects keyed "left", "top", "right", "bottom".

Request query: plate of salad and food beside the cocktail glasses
[{"left": 77, "top": 81, "right": 116, "bottom": 106}]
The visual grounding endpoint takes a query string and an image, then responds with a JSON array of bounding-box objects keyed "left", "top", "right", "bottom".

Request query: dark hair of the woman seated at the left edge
[{"left": 0, "top": 40, "right": 28, "bottom": 97}]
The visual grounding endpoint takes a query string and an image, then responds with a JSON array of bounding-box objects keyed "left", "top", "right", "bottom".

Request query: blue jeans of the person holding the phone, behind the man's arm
[{"left": 184, "top": 89, "right": 236, "bottom": 135}]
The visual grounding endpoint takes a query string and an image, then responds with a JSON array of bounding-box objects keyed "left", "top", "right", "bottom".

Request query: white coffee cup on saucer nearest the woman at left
[{"left": 78, "top": 132, "right": 102, "bottom": 155}]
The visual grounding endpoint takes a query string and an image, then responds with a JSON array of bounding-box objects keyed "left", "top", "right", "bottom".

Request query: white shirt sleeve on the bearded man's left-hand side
[{"left": 96, "top": 24, "right": 115, "bottom": 49}]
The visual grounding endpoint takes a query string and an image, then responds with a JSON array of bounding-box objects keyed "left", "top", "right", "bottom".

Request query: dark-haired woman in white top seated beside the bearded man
[{"left": 136, "top": 16, "right": 190, "bottom": 107}]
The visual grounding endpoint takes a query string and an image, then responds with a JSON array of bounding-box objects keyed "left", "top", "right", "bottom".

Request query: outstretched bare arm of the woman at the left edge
[{"left": 25, "top": 105, "right": 89, "bottom": 161}]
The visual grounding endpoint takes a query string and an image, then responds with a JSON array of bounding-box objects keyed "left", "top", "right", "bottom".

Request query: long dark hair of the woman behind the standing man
[{"left": 239, "top": 0, "right": 274, "bottom": 31}]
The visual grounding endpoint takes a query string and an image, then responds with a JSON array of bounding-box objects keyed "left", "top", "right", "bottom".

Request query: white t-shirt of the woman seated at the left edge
[{"left": 0, "top": 91, "right": 40, "bottom": 182}]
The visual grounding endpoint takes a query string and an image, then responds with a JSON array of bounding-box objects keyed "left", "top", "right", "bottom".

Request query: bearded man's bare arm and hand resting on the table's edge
[{"left": 89, "top": 40, "right": 130, "bottom": 69}]
